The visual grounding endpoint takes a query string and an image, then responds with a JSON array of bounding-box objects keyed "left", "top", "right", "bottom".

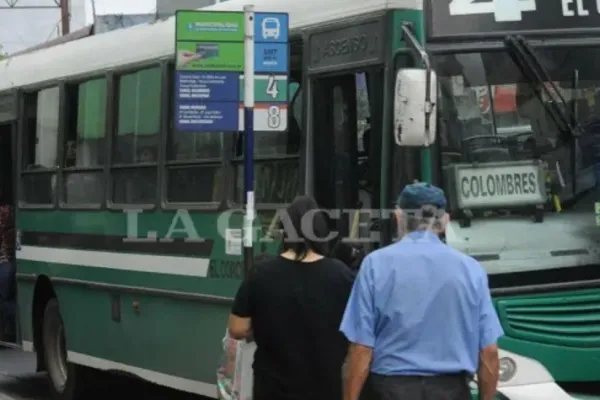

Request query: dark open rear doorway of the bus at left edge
[{"left": 0, "top": 93, "right": 18, "bottom": 345}]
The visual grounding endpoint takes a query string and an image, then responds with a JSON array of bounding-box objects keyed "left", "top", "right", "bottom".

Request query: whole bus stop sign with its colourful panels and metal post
[{"left": 174, "top": 5, "right": 289, "bottom": 274}]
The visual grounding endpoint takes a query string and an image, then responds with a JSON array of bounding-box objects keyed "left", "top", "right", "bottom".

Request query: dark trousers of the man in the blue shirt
[{"left": 369, "top": 374, "right": 471, "bottom": 400}]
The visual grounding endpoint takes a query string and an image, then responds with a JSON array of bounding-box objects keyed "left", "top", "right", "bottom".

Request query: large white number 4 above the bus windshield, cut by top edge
[{"left": 450, "top": 0, "right": 536, "bottom": 22}]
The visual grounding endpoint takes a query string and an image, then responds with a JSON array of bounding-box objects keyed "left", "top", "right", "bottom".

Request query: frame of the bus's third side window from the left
[{"left": 106, "top": 59, "right": 168, "bottom": 211}]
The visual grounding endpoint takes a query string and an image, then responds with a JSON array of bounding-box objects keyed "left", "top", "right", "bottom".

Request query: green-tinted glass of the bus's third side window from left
[{"left": 111, "top": 67, "right": 162, "bottom": 205}]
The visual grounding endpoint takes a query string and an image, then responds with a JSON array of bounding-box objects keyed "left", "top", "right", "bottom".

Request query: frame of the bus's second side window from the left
[{"left": 56, "top": 72, "right": 110, "bottom": 210}]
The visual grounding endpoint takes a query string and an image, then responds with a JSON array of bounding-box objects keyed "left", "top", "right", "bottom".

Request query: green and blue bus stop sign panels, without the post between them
[{"left": 175, "top": 10, "right": 290, "bottom": 132}]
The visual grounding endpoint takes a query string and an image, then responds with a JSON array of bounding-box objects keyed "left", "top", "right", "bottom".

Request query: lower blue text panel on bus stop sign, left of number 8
[{"left": 175, "top": 100, "right": 239, "bottom": 132}]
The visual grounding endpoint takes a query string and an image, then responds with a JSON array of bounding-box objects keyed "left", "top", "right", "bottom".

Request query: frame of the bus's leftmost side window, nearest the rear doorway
[{"left": 15, "top": 80, "right": 65, "bottom": 210}]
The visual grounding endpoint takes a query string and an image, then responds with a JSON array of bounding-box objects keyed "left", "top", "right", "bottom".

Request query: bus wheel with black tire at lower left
[{"left": 42, "top": 298, "right": 84, "bottom": 400}]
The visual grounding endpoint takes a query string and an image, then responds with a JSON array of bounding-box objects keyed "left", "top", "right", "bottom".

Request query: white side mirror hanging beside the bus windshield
[{"left": 394, "top": 68, "right": 437, "bottom": 146}]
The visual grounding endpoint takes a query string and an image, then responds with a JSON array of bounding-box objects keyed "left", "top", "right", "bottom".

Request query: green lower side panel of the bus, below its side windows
[{"left": 17, "top": 211, "right": 260, "bottom": 397}]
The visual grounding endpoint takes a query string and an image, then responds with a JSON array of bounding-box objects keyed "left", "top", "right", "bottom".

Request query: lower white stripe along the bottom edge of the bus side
[{"left": 67, "top": 351, "right": 217, "bottom": 398}]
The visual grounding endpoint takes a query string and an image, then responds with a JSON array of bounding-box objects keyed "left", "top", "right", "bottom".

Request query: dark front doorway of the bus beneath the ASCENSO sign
[{"left": 312, "top": 68, "right": 383, "bottom": 255}]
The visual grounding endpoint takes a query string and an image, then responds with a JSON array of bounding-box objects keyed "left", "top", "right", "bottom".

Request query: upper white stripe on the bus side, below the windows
[{"left": 16, "top": 244, "right": 210, "bottom": 278}]
